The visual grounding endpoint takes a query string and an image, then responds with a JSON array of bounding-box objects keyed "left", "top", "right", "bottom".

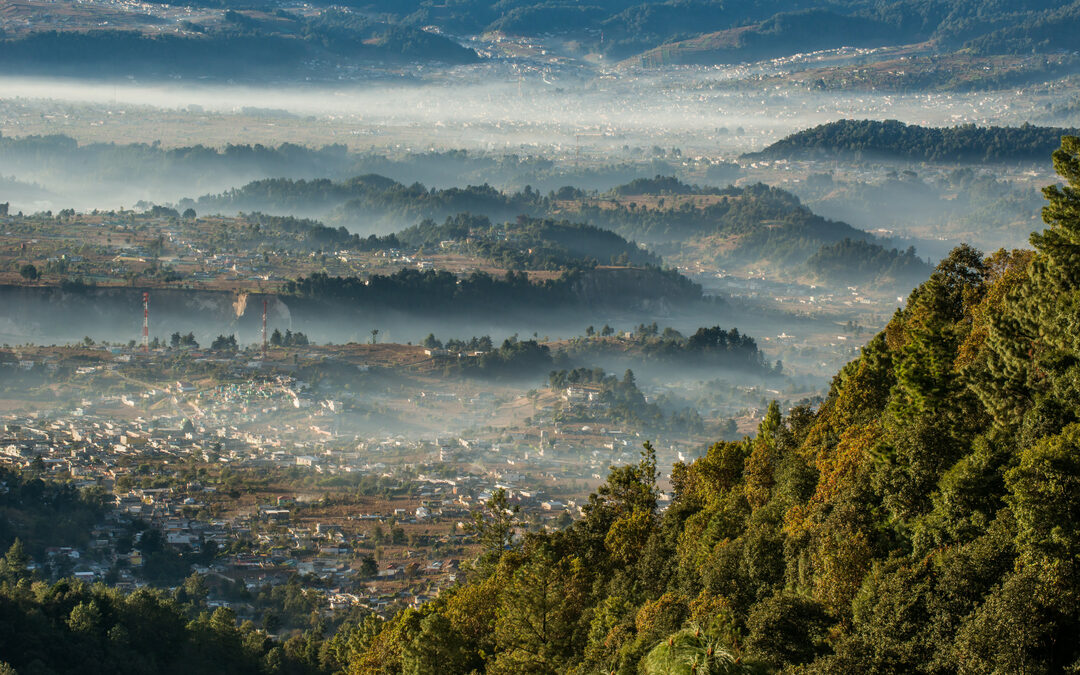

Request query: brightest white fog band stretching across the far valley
[{"left": 0, "top": 58, "right": 1066, "bottom": 212}]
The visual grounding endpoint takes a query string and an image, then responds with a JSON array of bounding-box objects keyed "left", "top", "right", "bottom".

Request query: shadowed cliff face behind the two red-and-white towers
[{"left": 0, "top": 269, "right": 701, "bottom": 345}]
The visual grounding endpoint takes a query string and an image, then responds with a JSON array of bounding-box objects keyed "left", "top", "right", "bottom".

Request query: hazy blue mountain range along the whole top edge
[{"left": 8, "top": 0, "right": 1080, "bottom": 77}]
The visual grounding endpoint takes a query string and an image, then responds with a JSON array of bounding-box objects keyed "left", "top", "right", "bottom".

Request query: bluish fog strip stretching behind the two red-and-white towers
[{"left": 0, "top": 286, "right": 859, "bottom": 375}]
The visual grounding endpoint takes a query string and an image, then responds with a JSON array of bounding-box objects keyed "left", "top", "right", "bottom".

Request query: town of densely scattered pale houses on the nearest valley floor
[{"left": 0, "top": 341, "right": 691, "bottom": 617}]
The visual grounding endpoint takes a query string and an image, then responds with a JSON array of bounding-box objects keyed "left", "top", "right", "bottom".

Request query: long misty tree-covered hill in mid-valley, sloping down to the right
[{"left": 198, "top": 174, "right": 911, "bottom": 289}]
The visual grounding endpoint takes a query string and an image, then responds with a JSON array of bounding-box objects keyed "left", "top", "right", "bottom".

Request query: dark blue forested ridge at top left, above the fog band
[{"left": 0, "top": 10, "right": 480, "bottom": 78}]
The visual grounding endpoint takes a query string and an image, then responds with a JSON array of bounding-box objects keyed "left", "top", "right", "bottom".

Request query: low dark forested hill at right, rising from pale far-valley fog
[{"left": 746, "top": 120, "right": 1077, "bottom": 162}]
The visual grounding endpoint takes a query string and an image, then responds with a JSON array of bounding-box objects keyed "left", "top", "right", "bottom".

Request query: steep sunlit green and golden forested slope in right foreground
[{"left": 327, "top": 137, "right": 1080, "bottom": 674}]
